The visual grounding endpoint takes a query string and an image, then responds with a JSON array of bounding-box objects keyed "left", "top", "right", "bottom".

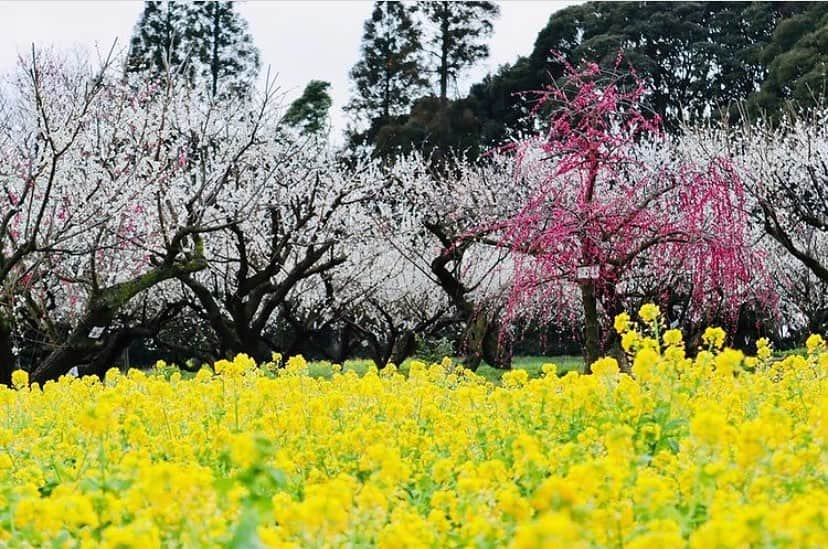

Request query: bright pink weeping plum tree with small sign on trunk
[{"left": 499, "top": 56, "right": 761, "bottom": 371}]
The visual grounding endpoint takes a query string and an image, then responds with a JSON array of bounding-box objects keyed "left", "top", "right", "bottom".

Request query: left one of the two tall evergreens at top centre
[{"left": 345, "top": 2, "right": 428, "bottom": 126}]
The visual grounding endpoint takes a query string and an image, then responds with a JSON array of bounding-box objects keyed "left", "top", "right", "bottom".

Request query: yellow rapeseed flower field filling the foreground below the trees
[{"left": 0, "top": 309, "right": 828, "bottom": 548}]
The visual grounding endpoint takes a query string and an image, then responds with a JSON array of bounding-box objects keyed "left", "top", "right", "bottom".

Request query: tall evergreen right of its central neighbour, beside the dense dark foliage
[{"left": 419, "top": 1, "right": 500, "bottom": 103}]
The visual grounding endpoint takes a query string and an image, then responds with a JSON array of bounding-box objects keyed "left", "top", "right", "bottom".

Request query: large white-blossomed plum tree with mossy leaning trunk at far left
[{"left": 0, "top": 48, "right": 274, "bottom": 382}]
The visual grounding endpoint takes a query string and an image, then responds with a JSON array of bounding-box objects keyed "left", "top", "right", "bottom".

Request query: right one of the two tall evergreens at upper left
[{"left": 187, "top": 2, "right": 259, "bottom": 96}]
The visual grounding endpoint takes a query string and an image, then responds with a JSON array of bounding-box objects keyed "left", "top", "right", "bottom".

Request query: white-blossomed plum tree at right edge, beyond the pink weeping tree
[{"left": 684, "top": 107, "right": 828, "bottom": 337}]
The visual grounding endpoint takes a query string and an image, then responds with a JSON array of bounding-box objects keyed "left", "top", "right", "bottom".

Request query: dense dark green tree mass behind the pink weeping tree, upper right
[{"left": 354, "top": 2, "right": 826, "bottom": 156}]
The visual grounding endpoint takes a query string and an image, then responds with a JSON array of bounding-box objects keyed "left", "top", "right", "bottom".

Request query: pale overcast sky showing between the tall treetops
[{"left": 0, "top": 0, "right": 576, "bottom": 140}]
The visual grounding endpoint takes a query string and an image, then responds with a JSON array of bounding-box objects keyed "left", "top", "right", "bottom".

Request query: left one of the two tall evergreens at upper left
[{"left": 127, "top": 2, "right": 194, "bottom": 81}]
